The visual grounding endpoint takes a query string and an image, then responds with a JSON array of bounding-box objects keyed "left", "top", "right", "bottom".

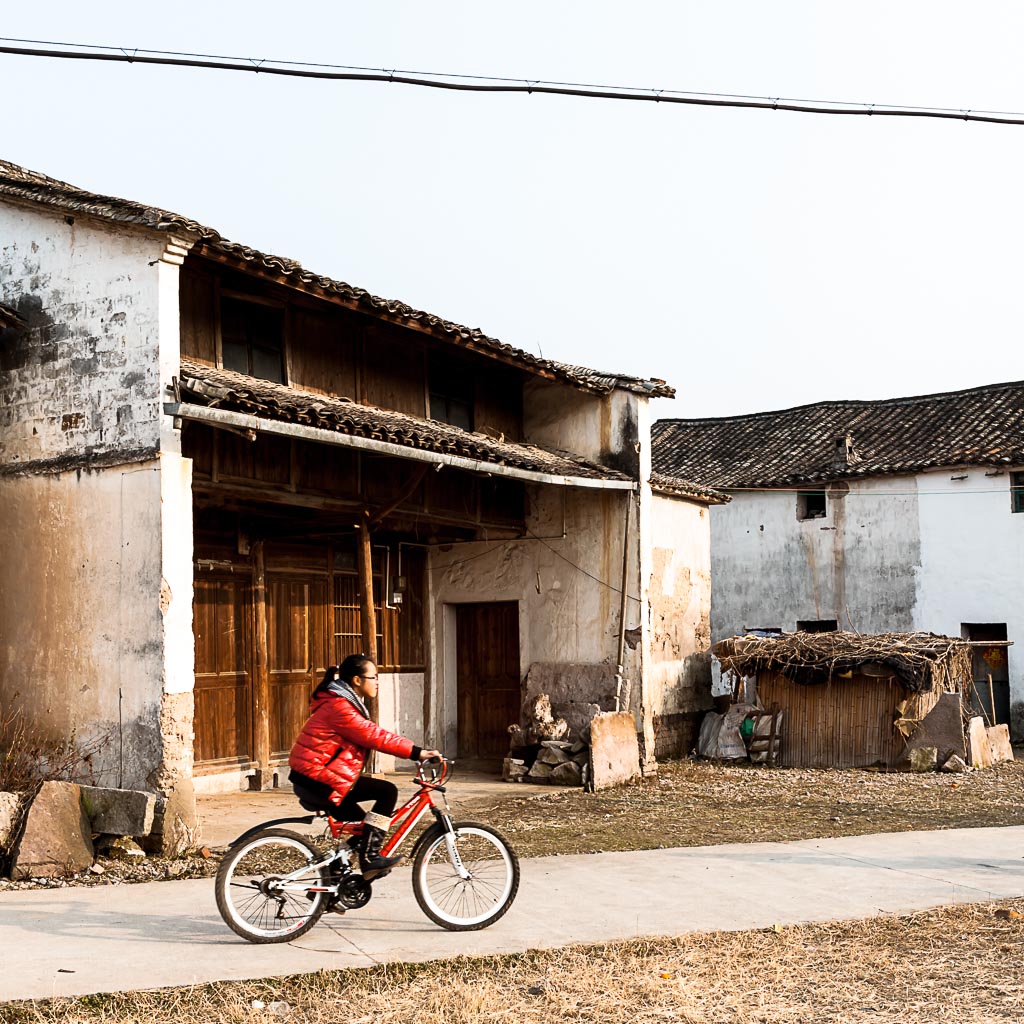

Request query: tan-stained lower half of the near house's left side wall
[{"left": 0, "top": 461, "right": 163, "bottom": 787}]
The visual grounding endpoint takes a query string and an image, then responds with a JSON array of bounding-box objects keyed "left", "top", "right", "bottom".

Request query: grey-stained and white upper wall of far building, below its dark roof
[{"left": 711, "top": 468, "right": 1024, "bottom": 736}]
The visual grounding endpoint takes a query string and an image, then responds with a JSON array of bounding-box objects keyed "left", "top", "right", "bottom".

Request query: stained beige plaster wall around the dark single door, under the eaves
[{"left": 428, "top": 486, "right": 641, "bottom": 751}]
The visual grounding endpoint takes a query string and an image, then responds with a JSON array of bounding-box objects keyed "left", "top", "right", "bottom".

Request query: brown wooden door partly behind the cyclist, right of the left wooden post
[{"left": 266, "top": 574, "right": 328, "bottom": 757}]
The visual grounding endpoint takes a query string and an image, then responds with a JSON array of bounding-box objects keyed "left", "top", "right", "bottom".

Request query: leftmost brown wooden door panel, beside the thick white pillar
[{"left": 193, "top": 575, "right": 253, "bottom": 763}]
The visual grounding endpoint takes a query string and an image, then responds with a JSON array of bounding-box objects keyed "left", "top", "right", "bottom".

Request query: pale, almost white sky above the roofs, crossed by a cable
[{"left": 0, "top": 0, "right": 1024, "bottom": 418}]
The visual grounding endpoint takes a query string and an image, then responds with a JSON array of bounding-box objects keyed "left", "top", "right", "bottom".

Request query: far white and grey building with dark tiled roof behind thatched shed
[{"left": 652, "top": 382, "right": 1024, "bottom": 736}]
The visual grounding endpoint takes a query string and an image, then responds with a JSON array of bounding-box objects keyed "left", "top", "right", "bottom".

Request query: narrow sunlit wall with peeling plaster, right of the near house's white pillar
[{"left": 646, "top": 495, "right": 712, "bottom": 757}]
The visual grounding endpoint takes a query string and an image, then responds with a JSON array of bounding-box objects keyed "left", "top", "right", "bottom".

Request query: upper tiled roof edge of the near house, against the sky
[{"left": 0, "top": 160, "right": 676, "bottom": 397}]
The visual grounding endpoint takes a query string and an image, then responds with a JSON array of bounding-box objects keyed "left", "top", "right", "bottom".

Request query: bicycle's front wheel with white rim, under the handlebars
[{"left": 413, "top": 821, "right": 519, "bottom": 932}]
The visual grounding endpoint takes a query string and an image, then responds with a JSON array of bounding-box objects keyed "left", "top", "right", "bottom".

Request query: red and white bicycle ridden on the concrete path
[{"left": 216, "top": 758, "right": 519, "bottom": 943}]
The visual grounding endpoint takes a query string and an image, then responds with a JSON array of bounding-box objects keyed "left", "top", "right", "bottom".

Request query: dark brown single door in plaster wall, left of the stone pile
[{"left": 456, "top": 601, "right": 521, "bottom": 758}]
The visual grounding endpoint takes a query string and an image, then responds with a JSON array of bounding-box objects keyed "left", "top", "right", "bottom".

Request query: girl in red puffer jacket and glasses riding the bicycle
[{"left": 288, "top": 654, "right": 441, "bottom": 880}]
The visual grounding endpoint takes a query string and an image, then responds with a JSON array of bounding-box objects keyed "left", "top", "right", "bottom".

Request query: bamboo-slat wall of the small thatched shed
[{"left": 758, "top": 672, "right": 939, "bottom": 768}]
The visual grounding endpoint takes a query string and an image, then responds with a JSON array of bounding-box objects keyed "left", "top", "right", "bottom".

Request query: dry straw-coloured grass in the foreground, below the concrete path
[{"left": 8, "top": 900, "right": 1024, "bottom": 1024}]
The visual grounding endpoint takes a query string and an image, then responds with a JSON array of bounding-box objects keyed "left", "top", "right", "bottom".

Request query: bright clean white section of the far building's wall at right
[{"left": 913, "top": 468, "right": 1024, "bottom": 736}]
